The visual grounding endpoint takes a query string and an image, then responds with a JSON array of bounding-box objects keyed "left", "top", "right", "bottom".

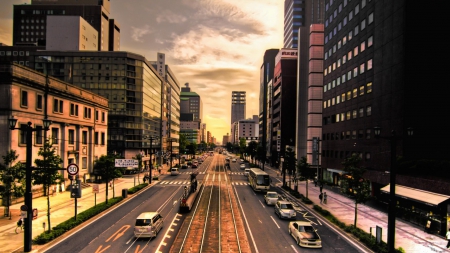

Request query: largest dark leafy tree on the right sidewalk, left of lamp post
[{"left": 341, "top": 154, "right": 371, "bottom": 227}]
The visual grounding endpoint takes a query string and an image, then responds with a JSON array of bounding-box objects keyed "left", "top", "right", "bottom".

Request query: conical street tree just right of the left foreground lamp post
[{"left": 32, "top": 141, "right": 64, "bottom": 231}]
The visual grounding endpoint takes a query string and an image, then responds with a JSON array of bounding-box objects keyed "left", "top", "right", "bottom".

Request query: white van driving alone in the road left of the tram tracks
[{"left": 134, "top": 212, "right": 164, "bottom": 238}]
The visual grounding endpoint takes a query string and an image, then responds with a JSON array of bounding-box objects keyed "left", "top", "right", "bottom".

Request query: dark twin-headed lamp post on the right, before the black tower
[{"left": 374, "top": 126, "right": 413, "bottom": 253}]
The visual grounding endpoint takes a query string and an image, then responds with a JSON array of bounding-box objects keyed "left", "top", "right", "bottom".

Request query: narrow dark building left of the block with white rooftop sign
[{"left": 258, "top": 49, "right": 280, "bottom": 164}]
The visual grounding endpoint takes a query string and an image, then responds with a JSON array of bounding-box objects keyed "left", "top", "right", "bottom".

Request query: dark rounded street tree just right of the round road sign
[{"left": 94, "top": 155, "right": 123, "bottom": 204}]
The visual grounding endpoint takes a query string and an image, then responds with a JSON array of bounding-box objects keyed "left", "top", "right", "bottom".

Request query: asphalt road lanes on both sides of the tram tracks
[{"left": 42, "top": 154, "right": 364, "bottom": 253}]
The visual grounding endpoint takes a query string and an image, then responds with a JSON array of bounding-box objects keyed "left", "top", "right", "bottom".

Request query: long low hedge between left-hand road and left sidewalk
[{"left": 33, "top": 183, "right": 148, "bottom": 245}]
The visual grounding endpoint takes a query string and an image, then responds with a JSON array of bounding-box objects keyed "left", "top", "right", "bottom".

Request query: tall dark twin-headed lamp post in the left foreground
[{"left": 8, "top": 117, "right": 52, "bottom": 252}]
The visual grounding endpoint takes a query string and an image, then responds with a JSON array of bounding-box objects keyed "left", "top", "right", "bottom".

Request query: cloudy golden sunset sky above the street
[{"left": 0, "top": 0, "right": 284, "bottom": 142}]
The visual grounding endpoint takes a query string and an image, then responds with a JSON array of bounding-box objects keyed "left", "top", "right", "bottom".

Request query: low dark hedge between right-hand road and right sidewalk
[{"left": 314, "top": 205, "right": 406, "bottom": 253}]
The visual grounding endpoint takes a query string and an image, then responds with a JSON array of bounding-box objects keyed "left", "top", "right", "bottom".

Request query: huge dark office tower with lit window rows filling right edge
[{"left": 321, "top": 0, "right": 450, "bottom": 233}]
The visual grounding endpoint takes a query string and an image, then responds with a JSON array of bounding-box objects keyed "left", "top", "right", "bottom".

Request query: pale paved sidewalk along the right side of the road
[{"left": 271, "top": 165, "right": 450, "bottom": 253}]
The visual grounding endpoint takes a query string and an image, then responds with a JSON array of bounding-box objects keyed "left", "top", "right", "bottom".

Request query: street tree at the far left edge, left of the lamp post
[{"left": 0, "top": 150, "right": 25, "bottom": 217}]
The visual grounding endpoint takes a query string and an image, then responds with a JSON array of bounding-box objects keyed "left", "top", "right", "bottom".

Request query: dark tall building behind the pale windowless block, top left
[{"left": 13, "top": 0, "right": 120, "bottom": 51}]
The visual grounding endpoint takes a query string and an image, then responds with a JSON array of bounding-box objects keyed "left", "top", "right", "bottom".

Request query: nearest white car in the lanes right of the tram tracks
[{"left": 289, "top": 221, "right": 322, "bottom": 248}]
